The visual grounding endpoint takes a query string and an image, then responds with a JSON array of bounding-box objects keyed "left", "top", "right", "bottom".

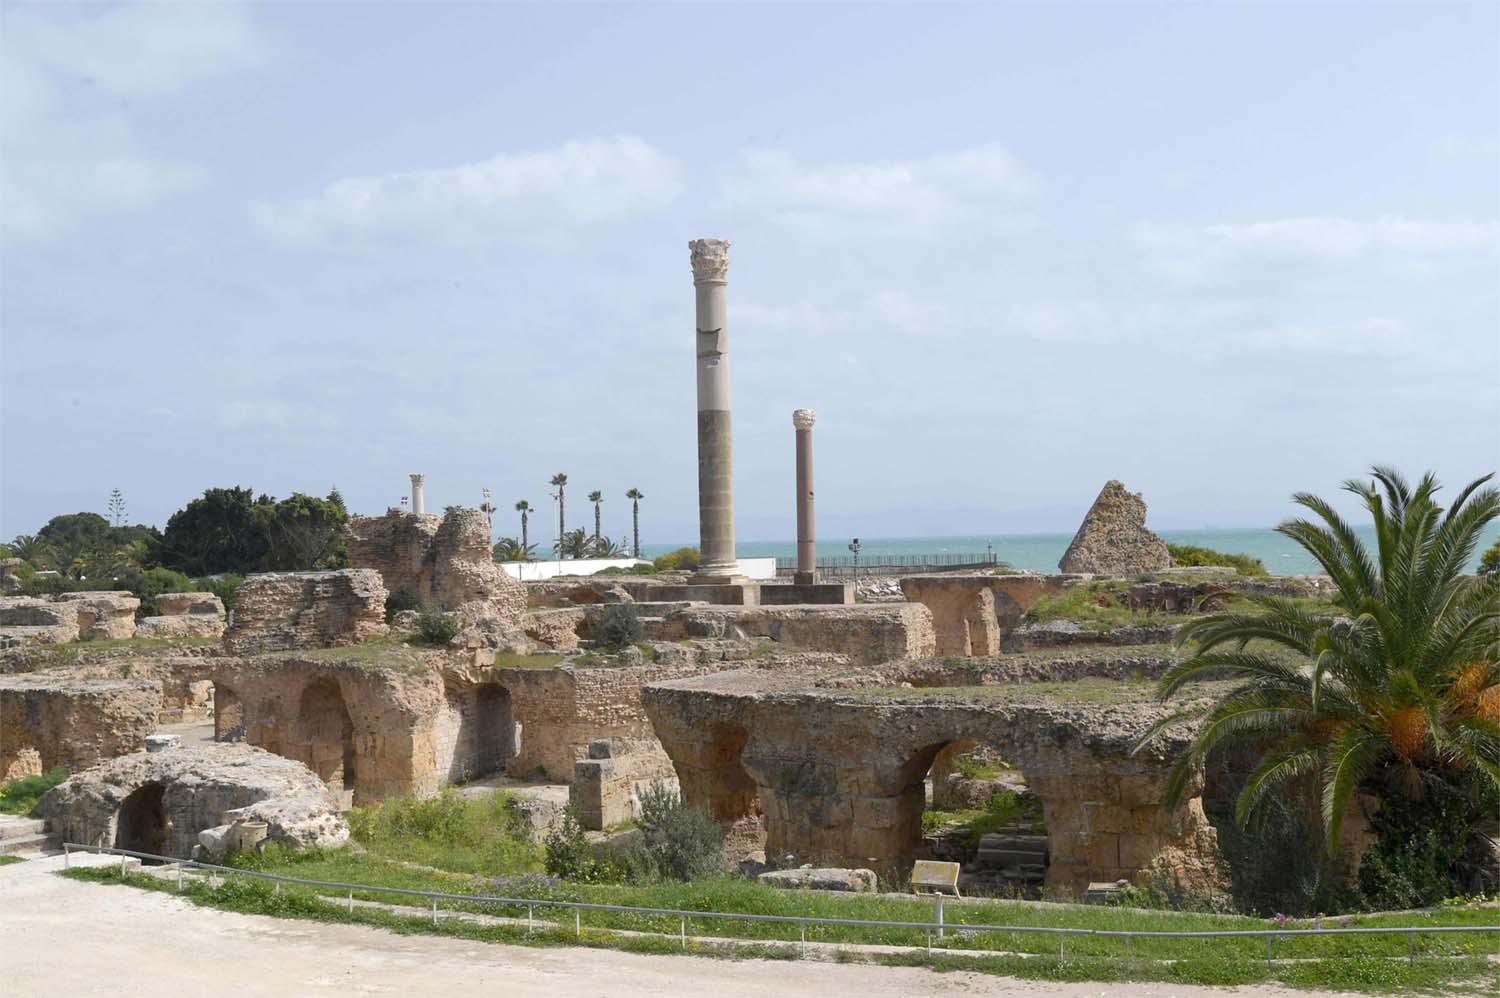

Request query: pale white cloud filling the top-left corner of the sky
[{"left": 0, "top": 3, "right": 264, "bottom": 239}]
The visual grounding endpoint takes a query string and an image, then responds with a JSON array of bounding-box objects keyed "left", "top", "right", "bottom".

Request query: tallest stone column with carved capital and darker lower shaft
[{"left": 687, "top": 239, "right": 738, "bottom": 582}]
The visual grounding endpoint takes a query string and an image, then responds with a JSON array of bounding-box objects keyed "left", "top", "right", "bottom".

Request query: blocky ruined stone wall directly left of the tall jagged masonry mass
[{"left": 224, "top": 569, "right": 386, "bottom": 654}]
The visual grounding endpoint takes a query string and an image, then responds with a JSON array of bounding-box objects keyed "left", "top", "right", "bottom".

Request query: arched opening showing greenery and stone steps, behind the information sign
[{"left": 902, "top": 738, "right": 1050, "bottom": 897}]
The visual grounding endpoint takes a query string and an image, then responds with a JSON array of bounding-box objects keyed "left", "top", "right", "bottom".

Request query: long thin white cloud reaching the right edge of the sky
[{"left": 1130, "top": 218, "right": 1500, "bottom": 284}]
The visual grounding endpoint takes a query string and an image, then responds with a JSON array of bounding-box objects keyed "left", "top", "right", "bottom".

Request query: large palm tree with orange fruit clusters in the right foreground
[{"left": 1142, "top": 467, "right": 1500, "bottom": 852}]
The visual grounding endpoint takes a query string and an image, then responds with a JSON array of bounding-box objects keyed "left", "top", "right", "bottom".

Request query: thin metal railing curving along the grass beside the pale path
[{"left": 63, "top": 842, "right": 1500, "bottom": 960}]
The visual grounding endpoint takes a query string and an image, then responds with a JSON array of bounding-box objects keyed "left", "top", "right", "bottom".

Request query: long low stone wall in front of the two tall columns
[{"left": 660, "top": 603, "right": 936, "bottom": 665}]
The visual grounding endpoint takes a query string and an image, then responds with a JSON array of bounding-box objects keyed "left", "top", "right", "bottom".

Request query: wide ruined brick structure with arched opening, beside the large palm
[{"left": 642, "top": 672, "right": 1218, "bottom": 893}]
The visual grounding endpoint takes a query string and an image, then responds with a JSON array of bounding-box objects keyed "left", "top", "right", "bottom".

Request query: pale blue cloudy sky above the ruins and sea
[{"left": 0, "top": 0, "right": 1500, "bottom": 543}]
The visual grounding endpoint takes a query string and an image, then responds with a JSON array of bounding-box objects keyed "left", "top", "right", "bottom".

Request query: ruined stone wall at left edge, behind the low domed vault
[{"left": 0, "top": 674, "right": 162, "bottom": 780}]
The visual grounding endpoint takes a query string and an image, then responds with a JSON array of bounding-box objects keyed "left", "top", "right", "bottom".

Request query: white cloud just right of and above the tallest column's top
[{"left": 720, "top": 144, "right": 1041, "bottom": 239}]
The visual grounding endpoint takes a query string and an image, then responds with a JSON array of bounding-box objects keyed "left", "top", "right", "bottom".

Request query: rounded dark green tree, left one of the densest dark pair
[{"left": 158, "top": 486, "right": 275, "bottom": 575}]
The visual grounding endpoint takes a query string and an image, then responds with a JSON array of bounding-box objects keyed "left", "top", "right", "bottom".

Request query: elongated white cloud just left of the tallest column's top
[{"left": 251, "top": 137, "right": 683, "bottom": 242}]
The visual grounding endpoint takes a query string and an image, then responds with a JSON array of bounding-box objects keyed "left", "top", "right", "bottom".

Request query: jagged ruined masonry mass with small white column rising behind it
[{"left": 350, "top": 507, "right": 527, "bottom": 644}]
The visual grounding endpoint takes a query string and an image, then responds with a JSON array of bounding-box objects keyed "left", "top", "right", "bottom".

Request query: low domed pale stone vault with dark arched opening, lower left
[{"left": 38, "top": 743, "right": 350, "bottom": 858}]
